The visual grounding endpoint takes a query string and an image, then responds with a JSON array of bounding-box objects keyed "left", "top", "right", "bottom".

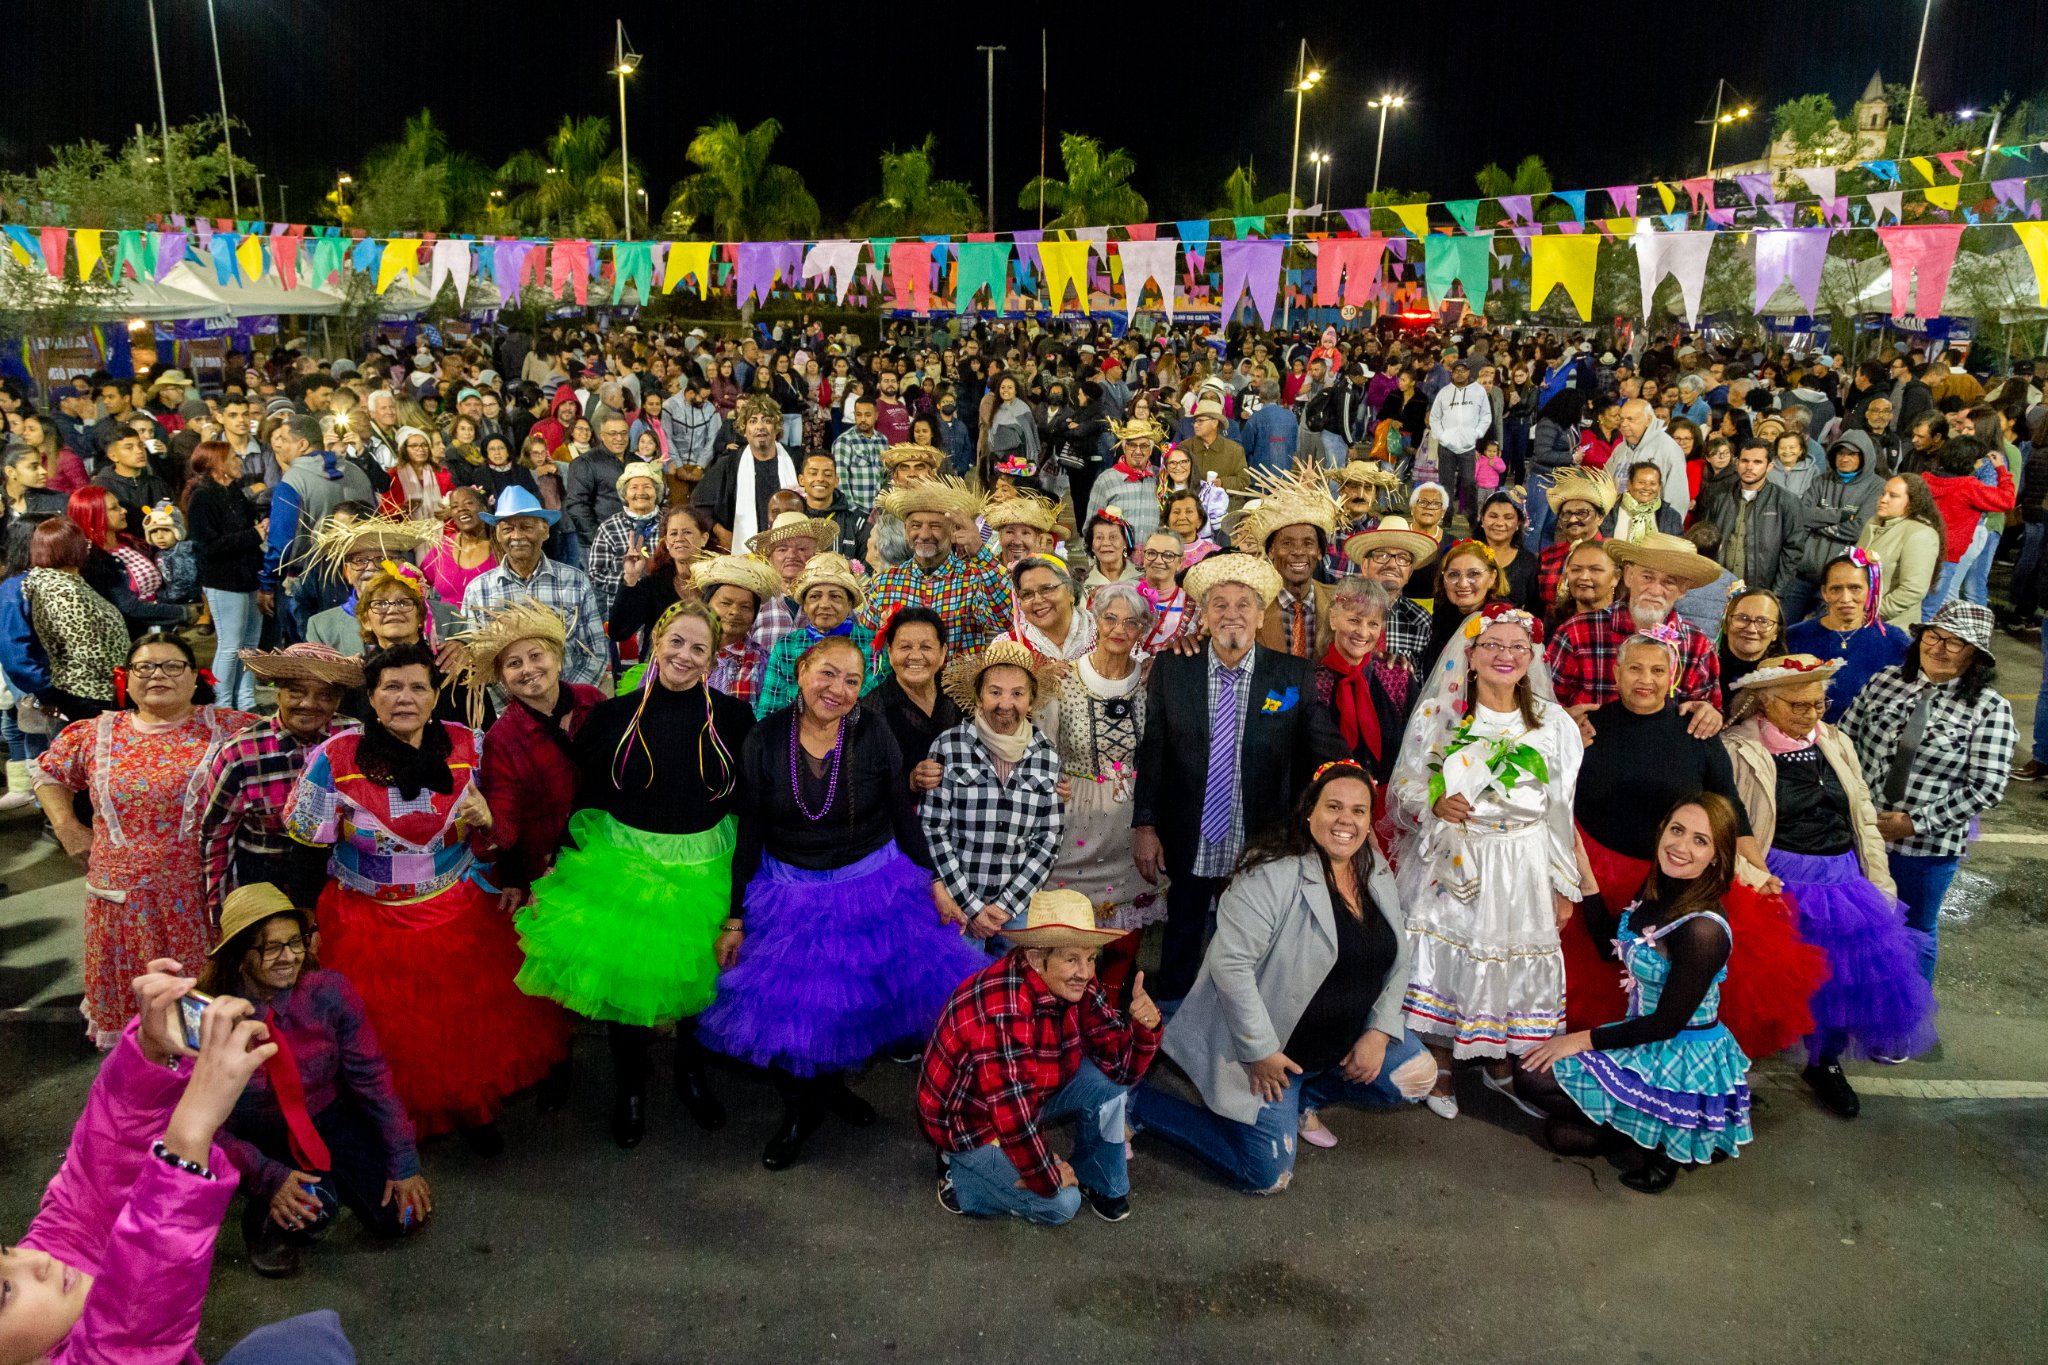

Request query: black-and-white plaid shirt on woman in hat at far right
[{"left": 1841, "top": 663, "right": 2019, "bottom": 857}]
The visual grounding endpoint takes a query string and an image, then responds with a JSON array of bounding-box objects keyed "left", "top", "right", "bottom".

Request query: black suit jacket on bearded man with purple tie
[{"left": 1130, "top": 649, "right": 1350, "bottom": 876}]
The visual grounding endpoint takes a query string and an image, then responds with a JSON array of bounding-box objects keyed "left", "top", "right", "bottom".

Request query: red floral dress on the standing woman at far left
[{"left": 35, "top": 706, "right": 256, "bottom": 1048}]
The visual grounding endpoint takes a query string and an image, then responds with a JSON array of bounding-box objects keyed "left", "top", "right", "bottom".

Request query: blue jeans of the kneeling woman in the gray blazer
[{"left": 1130, "top": 1031, "right": 1436, "bottom": 1195}]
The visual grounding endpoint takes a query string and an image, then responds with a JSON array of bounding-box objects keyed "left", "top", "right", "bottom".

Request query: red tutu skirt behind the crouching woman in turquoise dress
[{"left": 1559, "top": 829, "right": 1827, "bottom": 1060}]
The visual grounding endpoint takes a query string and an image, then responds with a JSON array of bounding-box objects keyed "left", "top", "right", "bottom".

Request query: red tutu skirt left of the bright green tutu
[{"left": 317, "top": 882, "right": 573, "bottom": 1138}]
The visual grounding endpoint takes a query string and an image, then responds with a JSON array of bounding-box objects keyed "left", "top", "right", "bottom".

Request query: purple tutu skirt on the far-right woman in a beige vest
[{"left": 1765, "top": 849, "right": 1935, "bottom": 1056}]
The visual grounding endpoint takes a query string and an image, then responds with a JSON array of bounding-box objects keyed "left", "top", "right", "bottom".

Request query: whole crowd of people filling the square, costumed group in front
[{"left": 0, "top": 319, "right": 2048, "bottom": 1363}]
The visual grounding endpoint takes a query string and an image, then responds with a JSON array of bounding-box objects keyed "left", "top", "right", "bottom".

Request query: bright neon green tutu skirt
[{"left": 514, "top": 810, "right": 733, "bottom": 1025}]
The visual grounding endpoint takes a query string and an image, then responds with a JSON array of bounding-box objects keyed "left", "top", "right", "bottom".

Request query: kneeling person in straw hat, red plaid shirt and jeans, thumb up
[{"left": 918, "top": 890, "right": 1159, "bottom": 1224}]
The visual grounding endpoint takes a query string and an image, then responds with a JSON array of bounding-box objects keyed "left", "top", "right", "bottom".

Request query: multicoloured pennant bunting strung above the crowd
[{"left": 0, "top": 141, "right": 2048, "bottom": 325}]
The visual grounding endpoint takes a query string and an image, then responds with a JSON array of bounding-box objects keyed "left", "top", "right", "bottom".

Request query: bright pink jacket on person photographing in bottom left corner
[{"left": 20, "top": 1019, "right": 236, "bottom": 1365}]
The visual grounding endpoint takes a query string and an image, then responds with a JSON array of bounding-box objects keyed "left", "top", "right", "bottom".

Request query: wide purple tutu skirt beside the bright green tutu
[{"left": 696, "top": 843, "right": 989, "bottom": 1076}]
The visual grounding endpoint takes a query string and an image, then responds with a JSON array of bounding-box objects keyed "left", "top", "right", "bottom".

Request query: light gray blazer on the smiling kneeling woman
[{"left": 1161, "top": 853, "right": 1415, "bottom": 1124}]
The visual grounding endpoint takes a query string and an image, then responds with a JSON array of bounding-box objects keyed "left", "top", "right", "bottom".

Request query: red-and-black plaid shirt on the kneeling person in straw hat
[{"left": 918, "top": 950, "right": 1159, "bottom": 1197}]
